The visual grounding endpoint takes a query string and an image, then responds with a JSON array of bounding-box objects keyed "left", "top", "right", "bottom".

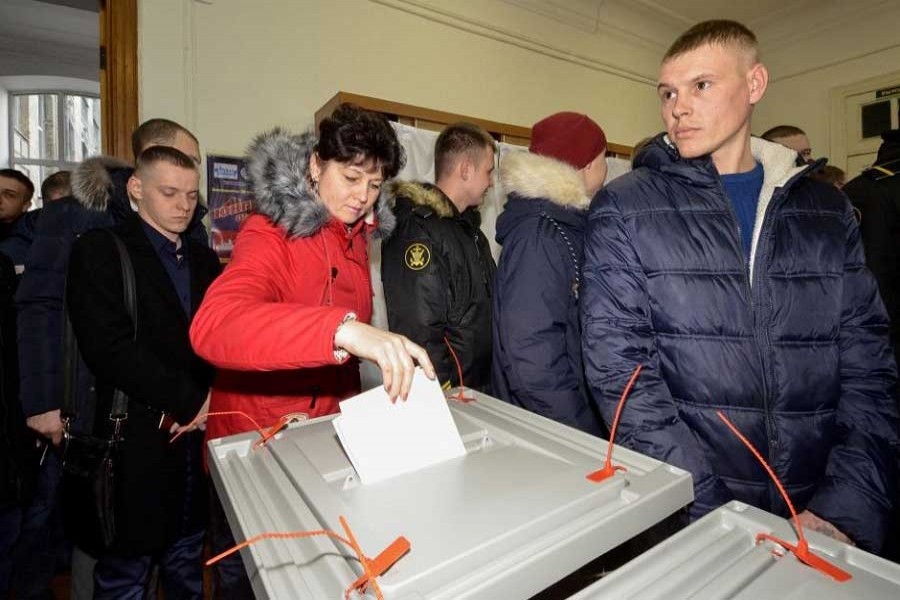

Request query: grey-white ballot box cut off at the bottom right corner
[{"left": 569, "top": 502, "right": 900, "bottom": 600}]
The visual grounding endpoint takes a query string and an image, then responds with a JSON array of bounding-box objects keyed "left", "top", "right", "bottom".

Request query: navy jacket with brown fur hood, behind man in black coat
[{"left": 16, "top": 157, "right": 207, "bottom": 417}]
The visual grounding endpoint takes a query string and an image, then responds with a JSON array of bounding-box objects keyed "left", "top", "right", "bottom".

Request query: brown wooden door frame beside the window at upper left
[{"left": 100, "top": 0, "right": 138, "bottom": 162}]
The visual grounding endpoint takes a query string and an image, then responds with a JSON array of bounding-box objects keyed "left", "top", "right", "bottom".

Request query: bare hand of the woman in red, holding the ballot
[{"left": 334, "top": 321, "right": 435, "bottom": 402}]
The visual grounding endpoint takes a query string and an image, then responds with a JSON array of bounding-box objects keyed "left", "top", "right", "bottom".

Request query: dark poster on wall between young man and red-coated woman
[{"left": 206, "top": 154, "right": 254, "bottom": 259}]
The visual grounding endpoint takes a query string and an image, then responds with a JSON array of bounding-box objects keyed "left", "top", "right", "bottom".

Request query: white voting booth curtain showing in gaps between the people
[{"left": 360, "top": 123, "right": 631, "bottom": 390}]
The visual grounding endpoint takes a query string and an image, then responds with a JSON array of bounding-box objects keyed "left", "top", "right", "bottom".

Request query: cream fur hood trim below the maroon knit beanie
[{"left": 500, "top": 152, "right": 591, "bottom": 210}]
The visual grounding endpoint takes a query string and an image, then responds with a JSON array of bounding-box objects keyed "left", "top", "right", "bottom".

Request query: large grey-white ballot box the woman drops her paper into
[{"left": 209, "top": 390, "right": 693, "bottom": 600}]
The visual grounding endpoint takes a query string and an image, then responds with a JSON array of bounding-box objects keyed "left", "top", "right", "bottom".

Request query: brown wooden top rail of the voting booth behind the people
[{"left": 315, "top": 92, "right": 634, "bottom": 159}]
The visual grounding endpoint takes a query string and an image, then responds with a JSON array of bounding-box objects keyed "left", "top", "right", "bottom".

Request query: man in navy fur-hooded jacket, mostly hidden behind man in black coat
[{"left": 14, "top": 119, "right": 207, "bottom": 600}]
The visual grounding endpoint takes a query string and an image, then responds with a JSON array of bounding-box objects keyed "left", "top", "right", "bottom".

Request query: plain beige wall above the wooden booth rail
[{"left": 139, "top": 0, "right": 660, "bottom": 158}]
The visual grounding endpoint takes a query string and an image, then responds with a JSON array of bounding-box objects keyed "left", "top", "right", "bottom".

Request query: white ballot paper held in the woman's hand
[{"left": 333, "top": 368, "right": 466, "bottom": 484}]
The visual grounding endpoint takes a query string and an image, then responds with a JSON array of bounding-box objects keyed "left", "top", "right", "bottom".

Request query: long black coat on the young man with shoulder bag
[{"left": 63, "top": 215, "right": 221, "bottom": 556}]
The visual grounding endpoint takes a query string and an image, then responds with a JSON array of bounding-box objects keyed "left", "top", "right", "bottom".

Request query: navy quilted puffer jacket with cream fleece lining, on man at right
[{"left": 582, "top": 136, "right": 898, "bottom": 550}]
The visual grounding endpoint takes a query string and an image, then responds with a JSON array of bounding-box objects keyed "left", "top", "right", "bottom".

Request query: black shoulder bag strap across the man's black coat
[{"left": 60, "top": 229, "right": 137, "bottom": 421}]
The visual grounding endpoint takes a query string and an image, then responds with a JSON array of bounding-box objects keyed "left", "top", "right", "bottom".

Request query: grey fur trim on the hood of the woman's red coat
[{"left": 247, "top": 127, "right": 396, "bottom": 237}]
